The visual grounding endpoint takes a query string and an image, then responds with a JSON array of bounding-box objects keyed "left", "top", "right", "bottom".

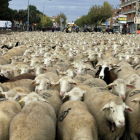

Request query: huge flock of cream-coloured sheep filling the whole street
[{"left": 0, "top": 32, "right": 140, "bottom": 140}]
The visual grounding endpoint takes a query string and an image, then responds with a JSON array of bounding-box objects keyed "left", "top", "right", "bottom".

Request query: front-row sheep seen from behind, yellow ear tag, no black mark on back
[{"left": 9, "top": 92, "right": 56, "bottom": 140}]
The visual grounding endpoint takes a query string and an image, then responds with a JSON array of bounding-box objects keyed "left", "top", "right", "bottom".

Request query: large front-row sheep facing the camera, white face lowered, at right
[{"left": 84, "top": 87, "right": 133, "bottom": 140}]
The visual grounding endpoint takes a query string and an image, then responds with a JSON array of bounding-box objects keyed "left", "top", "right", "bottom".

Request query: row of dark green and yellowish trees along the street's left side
[{"left": 0, "top": 0, "right": 67, "bottom": 28}]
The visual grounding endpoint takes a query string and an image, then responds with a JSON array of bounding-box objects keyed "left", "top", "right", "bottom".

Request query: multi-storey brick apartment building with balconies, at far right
[{"left": 120, "top": 0, "right": 140, "bottom": 33}]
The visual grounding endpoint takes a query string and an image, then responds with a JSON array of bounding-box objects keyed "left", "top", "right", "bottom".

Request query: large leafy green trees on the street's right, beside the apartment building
[{"left": 75, "top": 1, "right": 113, "bottom": 27}]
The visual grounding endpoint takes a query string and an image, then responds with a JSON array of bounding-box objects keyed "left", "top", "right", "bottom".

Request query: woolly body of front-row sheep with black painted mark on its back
[{"left": 57, "top": 101, "right": 98, "bottom": 140}]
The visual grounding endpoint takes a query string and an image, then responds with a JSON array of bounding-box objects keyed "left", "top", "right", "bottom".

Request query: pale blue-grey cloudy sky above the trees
[{"left": 9, "top": 0, "right": 121, "bottom": 22}]
